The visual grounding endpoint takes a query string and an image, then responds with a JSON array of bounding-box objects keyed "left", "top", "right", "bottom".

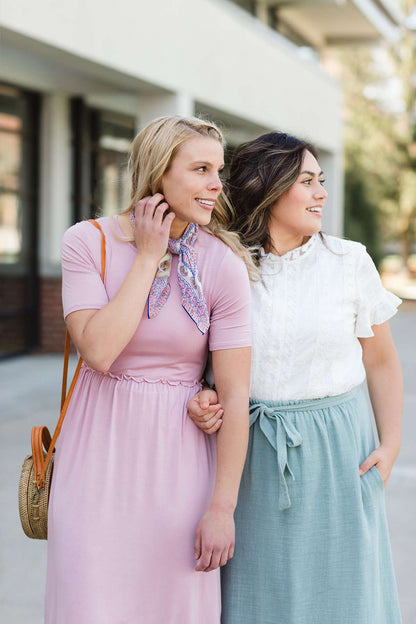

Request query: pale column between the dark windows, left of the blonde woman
[{"left": 39, "top": 94, "right": 72, "bottom": 276}]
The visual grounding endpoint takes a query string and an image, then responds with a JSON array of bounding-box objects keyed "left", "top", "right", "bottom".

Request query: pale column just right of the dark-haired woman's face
[{"left": 319, "top": 150, "right": 344, "bottom": 236}]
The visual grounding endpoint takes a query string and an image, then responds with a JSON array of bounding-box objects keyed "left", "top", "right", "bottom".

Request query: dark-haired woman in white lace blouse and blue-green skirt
[{"left": 189, "top": 132, "right": 402, "bottom": 624}]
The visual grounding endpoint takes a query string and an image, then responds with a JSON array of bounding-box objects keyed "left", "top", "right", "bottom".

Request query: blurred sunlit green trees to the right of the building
[{"left": 337, "top": 0, "right": 416, "bottom": 266}]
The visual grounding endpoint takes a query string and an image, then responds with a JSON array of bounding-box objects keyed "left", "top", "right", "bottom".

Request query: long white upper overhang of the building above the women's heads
[{"left": 0, "top": 0, "right": 342, "bottom": 152}]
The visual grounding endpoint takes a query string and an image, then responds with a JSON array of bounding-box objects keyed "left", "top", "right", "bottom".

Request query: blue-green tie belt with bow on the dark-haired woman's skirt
[{"left": 249, "top": 388, "right": 357, "bottom": 510}]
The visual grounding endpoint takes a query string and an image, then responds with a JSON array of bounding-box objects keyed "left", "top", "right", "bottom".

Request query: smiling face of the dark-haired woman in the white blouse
[{"left": 269, "top": 150, "right": 328, "bottom": 236}]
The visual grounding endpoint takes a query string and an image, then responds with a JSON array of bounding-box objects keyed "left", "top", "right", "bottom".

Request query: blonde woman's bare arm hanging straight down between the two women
[{"left": 195, "top": 347, "right": 251, "bottom": 572}]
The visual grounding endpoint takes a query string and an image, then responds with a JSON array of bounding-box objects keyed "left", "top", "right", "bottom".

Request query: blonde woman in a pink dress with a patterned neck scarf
[{"left": 46, "top": 117, "right": 254, "bottom": 624}]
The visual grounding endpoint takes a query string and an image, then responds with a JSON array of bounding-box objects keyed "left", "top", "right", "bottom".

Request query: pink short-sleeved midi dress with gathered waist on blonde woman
[{"left": 45, "top": 217, "right": 250, "bottom": 624}]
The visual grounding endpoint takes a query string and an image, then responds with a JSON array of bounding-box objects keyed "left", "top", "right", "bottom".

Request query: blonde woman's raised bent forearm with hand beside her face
[{"left": 66, "top": 194, "right": 174, "bottom": 372}]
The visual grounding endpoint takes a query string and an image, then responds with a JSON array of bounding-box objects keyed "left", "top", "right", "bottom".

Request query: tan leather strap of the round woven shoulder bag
[{"left": 32, "top": 219, "right": 105, "bottom": 488}]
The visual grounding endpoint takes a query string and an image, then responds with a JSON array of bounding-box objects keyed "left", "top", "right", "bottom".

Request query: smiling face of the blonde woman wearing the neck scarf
[{"left": 162, "top": 136, "right": 224, "bottom": 236}]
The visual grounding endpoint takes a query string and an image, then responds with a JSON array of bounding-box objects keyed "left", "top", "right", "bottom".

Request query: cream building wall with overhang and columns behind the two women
[{"left": 0, "top": 0, "right": 343, "bottom": 348}]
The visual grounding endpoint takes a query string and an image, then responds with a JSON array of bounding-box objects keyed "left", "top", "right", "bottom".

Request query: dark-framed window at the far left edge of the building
[{"left": 0, "top": 84, "right": 40, "bottom": 356}]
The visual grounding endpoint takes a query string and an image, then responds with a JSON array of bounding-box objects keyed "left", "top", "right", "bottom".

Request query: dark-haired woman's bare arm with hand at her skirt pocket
[{"left": 359, "top": 322, "right": 403, "bottom": 485}]
